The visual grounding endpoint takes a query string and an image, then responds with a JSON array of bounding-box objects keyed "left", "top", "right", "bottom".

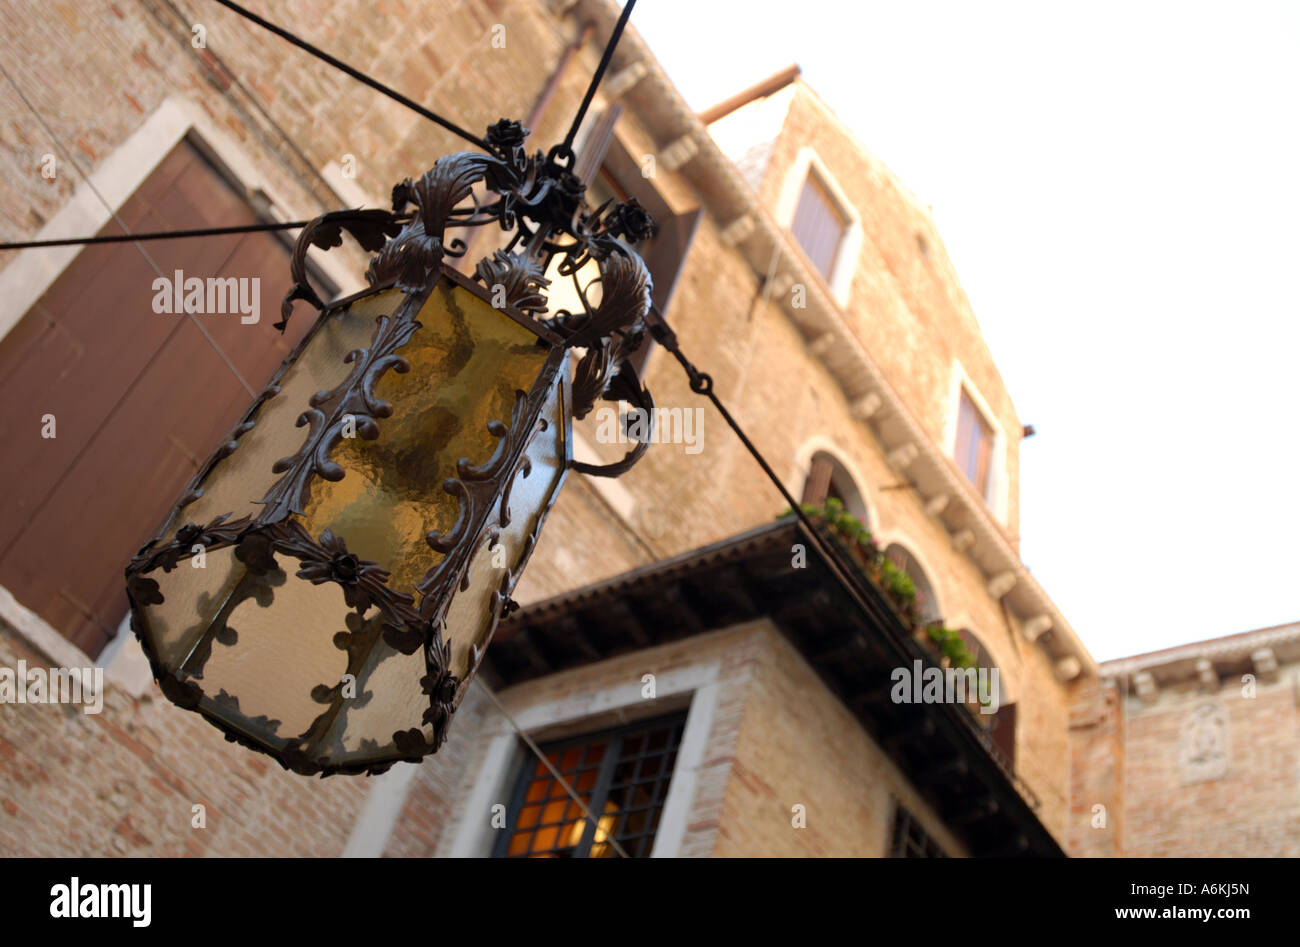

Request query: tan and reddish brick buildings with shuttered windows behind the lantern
[{"left": 0, "top": 0, "right": 1297, "bottom": 856}]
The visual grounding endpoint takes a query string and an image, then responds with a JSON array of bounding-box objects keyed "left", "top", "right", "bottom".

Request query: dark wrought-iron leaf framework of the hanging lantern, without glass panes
[{"left": 126, "top": 120, "right": 654, "bottom": 775}]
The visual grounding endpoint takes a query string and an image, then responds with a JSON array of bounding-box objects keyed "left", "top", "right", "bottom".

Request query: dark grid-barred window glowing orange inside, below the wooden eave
[{"left": 493, "top": 713, "right": 686, "bottom": 859}]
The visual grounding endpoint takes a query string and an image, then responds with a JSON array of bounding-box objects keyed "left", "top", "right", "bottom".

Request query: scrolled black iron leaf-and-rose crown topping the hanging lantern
[{"left": 276, "top": 118, "right": 657, "bottom": 477}]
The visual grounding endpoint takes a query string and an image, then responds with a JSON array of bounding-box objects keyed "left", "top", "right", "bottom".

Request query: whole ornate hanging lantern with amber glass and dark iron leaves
[{"left": 126, "top": 120, "right": 654, "bottom": 775}]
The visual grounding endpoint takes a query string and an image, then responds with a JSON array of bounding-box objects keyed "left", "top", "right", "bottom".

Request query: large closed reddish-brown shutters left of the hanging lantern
[{"left": 0, "top": 142, "right": 312, "bottom": 656}]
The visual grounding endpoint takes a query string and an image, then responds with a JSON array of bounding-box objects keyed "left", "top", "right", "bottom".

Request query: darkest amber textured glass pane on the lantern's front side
[{"left": 297, "top": 280, "right": 547, "bottom": 592}]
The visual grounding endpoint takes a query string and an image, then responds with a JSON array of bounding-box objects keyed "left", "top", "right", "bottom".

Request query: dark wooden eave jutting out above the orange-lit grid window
[{"left": 486, "top": 518, "right": 1062, "bottom": 856}]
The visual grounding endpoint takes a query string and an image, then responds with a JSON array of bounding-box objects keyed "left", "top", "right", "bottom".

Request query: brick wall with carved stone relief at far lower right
[{"left": 1069, "top": 663, "right": 1300, "bottom": 857}]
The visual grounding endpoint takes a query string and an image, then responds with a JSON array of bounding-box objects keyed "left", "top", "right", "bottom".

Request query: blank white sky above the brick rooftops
[{"left": 632, "top": 0, "right": 1300, "bottom": 660}]
